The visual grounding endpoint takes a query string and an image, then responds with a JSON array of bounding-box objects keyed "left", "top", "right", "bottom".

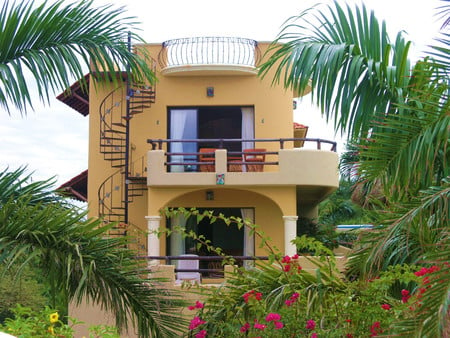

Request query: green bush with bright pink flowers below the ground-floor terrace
[{"left": 183, "top": 239, "right": 436, "bottom": 338}]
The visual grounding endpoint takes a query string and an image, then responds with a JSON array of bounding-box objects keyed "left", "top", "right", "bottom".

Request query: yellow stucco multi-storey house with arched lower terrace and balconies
[{"left": 58, "top": 38, "right": 338, "bottom": 278}]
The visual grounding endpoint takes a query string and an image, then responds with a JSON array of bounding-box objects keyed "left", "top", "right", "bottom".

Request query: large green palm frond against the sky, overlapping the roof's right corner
[{"left": 260, "top": 1, "right": 410, "bottom": 139}]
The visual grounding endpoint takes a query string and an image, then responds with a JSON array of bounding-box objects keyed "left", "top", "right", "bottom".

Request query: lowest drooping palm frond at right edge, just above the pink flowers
[{"left": 349, "top": 177, "right": 450, "bottom": 277}]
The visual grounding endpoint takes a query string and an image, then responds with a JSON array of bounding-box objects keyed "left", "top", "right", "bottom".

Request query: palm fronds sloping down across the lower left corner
[{"left": 0, "top": 168, "right": 185, "bottom": 337}]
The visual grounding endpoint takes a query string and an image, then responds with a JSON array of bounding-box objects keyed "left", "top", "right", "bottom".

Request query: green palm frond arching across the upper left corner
[{"left": 0, "top": 0, "right": 155, "bottom": 112}]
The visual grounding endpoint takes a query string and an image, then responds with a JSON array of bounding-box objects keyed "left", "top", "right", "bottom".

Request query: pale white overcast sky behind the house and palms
[{"left": 0, "top": 0, "right": 442, "bottom": 187}]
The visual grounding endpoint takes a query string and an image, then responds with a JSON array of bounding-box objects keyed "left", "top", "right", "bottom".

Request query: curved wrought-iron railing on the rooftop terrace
[{"left": 158, "top": 37, "right": 260, "bottom": 69}]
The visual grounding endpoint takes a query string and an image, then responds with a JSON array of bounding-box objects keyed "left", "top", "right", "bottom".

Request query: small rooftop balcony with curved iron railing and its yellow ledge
[{"left": 158, "top": 37, "right": 260, "bottom": 76}]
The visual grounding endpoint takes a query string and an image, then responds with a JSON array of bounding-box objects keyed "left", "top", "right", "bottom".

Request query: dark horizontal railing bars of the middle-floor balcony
[{"left": 147, "top": 138, "right": 337, "bottom": 172}]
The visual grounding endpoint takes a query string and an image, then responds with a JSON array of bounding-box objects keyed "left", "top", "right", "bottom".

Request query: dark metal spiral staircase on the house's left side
[{"left": 98, "top": 79, "right": 156, "bottom": 255}]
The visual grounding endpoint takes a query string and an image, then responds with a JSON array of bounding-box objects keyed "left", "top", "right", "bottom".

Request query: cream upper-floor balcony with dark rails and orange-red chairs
[{"left": 147, "top": 138, "right": 339, "bottom": 200}]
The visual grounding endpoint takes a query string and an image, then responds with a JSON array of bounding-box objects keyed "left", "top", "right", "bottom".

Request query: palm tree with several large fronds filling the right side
[{"left": 261, "top": 2, "right": 450, "bottom": 336}]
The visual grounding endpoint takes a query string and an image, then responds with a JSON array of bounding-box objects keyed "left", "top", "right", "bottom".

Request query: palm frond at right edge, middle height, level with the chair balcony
[{"left": 358, "top": 66, "right": 450, "bottom": 201}]
